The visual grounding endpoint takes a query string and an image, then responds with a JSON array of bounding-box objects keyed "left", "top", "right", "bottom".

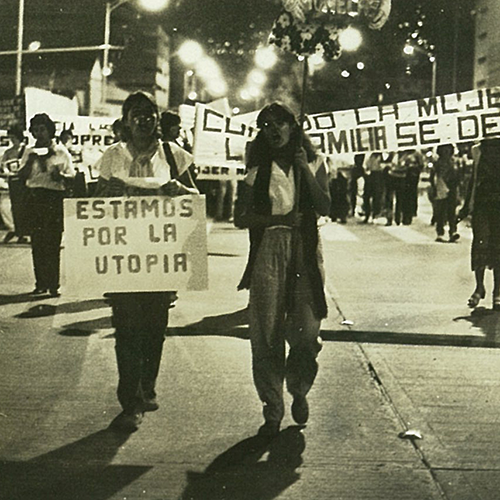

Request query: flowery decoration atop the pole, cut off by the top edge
[{"left": 269, "top": 0, "right": 391, "bottom": 60}]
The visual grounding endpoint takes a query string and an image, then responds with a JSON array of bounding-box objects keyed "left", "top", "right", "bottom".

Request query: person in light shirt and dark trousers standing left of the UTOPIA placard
[{"left": 19, "top": 113, "right": 75, "bottom": 297}]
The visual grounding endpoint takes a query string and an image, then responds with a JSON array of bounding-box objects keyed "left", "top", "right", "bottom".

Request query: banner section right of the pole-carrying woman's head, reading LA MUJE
[{"left": 304, "top": 87, "right": 500, "bottom": 155}]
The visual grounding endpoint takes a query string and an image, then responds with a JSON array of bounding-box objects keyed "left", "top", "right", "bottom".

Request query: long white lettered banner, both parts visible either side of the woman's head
[{"left": 194, "top": 87, "right": 500, "bottom": 167}]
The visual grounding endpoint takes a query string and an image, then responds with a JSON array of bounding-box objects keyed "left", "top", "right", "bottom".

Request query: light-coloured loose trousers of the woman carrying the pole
[{"left": 249, "top": 227, "right": 321, "bottom": 422}]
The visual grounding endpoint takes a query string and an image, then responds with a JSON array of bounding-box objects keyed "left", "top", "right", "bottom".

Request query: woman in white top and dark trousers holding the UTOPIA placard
[{"left": 95, "top": 92, "right": 198, "bottom": 432}]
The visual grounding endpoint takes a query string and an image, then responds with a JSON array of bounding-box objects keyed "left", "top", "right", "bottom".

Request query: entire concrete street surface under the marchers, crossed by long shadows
[{"left": 0, "top": 193, "right": 500, "bottom": 500}]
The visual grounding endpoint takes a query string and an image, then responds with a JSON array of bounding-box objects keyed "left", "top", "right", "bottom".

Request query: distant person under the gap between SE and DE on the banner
[{"left": 430, "top": 144, "right": 460, "bottom": 243}]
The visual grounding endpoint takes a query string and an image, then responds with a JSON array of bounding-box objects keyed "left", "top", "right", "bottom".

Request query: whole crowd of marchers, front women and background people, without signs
[{"left": 0, "top": 92, "right": 500, "bottom": 437}]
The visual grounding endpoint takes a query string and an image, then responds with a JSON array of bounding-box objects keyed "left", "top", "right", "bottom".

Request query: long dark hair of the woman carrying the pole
[{"left": 246, "top": 102, "right": 316, "bottom": 168}]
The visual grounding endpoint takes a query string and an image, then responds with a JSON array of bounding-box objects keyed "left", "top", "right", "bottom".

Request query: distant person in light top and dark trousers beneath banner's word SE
[{"left": 385, "top": 150, "right": 407, "bottom": 226}]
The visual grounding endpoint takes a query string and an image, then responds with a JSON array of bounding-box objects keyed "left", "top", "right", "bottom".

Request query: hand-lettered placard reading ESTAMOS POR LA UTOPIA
[{"left": 63, "top": 196, "right": 208, "bottom": 297}]
